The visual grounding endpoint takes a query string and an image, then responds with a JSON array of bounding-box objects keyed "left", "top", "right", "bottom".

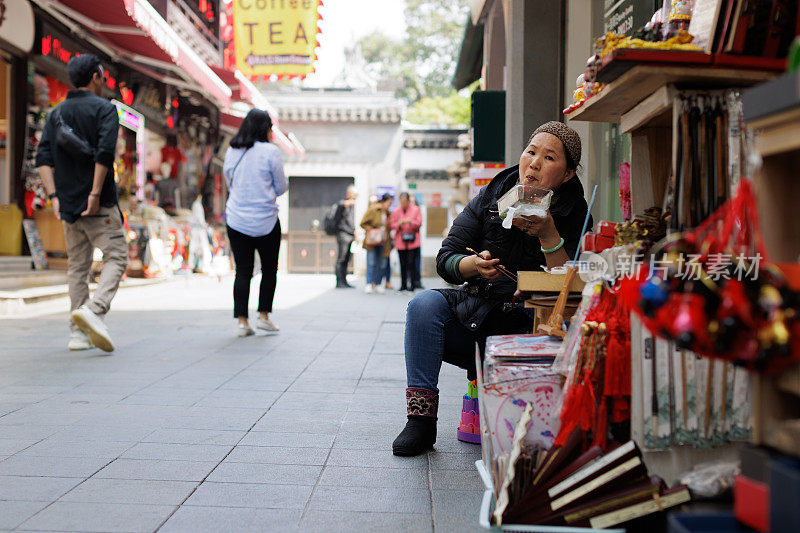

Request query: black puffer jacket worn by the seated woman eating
[{"left": 436, "top": 165, "right": 591, "bottom": 335}]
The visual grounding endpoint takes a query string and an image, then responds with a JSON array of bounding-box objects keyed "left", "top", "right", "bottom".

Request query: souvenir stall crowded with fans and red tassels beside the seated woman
[{"left": 459, "top": 0, "right": 800, "bottom": 532}]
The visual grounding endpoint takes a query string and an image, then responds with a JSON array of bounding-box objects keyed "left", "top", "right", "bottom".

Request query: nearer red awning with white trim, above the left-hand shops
[{"left": 50, "top": 0, "right": 232, "bottom": 107}]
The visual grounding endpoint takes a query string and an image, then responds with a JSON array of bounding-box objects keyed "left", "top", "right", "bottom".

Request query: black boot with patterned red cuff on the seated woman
[{"left": 392, "top": 387, "right": 439, "bottom": 457}]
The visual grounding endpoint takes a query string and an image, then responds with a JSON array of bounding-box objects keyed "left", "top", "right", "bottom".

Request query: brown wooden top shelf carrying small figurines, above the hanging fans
[{"left": 567, "top": 65, "right": 777, "bottom": 123}]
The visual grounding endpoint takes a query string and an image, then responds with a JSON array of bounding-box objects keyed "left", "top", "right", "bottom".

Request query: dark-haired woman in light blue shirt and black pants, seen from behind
[{"left": 222, "top": 109, "right": 289, "bottom": 337}]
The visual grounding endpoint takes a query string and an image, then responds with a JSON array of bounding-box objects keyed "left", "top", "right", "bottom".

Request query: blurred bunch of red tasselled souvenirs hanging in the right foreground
[{"left": 620, "top": 180, "right": 800, "bottom": 373}]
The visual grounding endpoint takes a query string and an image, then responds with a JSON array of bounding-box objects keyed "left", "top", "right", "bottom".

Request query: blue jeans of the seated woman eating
[{"left": 405, "top": 290, "right": 486, "bottom": 392}]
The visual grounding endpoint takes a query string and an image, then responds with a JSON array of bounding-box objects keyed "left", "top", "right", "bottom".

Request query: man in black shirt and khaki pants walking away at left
[{"left": 36, "top": 54, "right": 128, "bottom": 352}]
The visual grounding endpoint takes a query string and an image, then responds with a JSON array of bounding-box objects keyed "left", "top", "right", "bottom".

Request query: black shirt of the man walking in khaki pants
[{"left": 36, "top": 89, "right": 119, "bottom": 224}]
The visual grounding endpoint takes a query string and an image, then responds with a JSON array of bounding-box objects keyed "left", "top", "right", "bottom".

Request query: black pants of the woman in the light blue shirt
[{"left": 228, "top": 221, "right": 281, "bottom": 318}]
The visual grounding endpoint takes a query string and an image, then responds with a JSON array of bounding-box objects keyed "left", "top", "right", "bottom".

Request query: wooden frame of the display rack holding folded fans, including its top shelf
[{"left": 567, "top": 65, "right": 784, "bottom": 483}]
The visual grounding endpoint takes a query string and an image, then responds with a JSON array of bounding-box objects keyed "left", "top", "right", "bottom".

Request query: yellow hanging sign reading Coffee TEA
[{"left": 233, "top": 0, "right": 322, "bottom": 76}]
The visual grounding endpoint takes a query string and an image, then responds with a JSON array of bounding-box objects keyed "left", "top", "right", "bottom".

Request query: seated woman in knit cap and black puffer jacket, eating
[{"left": 392, "top": 122, "right": 588, "bottom": 456}]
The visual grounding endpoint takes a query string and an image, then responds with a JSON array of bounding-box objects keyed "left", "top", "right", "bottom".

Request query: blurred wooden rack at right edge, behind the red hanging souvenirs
[{"left": 743, "top": 72, "right": 800, "bottom": 456}]
